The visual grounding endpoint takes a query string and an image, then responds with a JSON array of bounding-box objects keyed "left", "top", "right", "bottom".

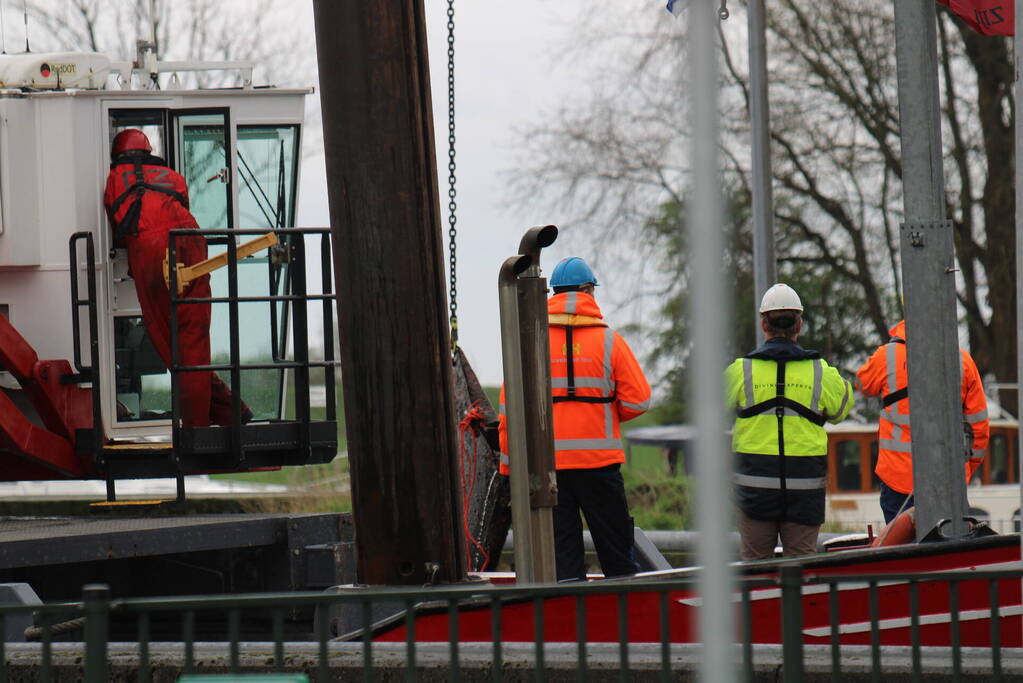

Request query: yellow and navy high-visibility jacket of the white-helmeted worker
[{"left": 724, "top": 337, "right": 852, "bottom": 525}]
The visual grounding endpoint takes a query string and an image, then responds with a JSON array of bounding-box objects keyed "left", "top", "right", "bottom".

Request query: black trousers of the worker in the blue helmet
[{"left": 553, "top": 464, "right": 639, "bottom": 581}]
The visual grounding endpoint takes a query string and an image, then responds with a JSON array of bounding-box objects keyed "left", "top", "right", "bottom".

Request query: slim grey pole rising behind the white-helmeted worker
[{"left": 746, "top": 0, "right": 777, "bottom": 342}]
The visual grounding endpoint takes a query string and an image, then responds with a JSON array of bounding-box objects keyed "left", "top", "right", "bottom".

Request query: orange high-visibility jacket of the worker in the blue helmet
[{"left": 498, "top": 291, "right": 650, "bottom": 474}]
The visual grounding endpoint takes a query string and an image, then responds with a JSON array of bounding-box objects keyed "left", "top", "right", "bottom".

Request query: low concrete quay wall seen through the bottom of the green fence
[{"left": 5, "top": 642, "right": 1023, "bottom": 683}]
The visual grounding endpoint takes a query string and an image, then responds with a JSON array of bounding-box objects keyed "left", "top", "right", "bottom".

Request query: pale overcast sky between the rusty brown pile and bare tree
[{"left": 299, "top": 0, "right": 638, "bottom": 384}]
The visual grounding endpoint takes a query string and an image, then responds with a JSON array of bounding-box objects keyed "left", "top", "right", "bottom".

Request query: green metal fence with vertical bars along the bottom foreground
[{"left": 0, "top": 566, "right": 1023, "bottom": 683}]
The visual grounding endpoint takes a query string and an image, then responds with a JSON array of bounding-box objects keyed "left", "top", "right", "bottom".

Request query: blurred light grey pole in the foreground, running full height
[{"left": 679, "top": 0, "right": 739, "bottom": 683}]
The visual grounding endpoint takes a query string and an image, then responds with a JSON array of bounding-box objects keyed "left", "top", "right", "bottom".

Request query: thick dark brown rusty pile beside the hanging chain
[{"left": 313, "top": 0, "right": 464, "bottom": 585}]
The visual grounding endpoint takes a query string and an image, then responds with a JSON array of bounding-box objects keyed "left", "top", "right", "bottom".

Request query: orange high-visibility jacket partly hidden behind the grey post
[{"left": 856, "top": 321, "right": 990, "bottom": 493}]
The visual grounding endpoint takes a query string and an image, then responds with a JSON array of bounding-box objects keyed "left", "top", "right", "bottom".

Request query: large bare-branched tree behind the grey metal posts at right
[{"left": 515, "top": 0, "right": 1016, "bottom": 413}]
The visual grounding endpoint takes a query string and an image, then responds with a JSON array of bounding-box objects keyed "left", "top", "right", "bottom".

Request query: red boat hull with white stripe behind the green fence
[{"left": 375, "top": 536, "right": 1023, "bottom": 647}]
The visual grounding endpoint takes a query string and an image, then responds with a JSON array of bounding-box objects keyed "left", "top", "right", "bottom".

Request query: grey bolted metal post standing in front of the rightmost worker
[{"left": 893, "top": 0, "right": 967, "bottom": 540}]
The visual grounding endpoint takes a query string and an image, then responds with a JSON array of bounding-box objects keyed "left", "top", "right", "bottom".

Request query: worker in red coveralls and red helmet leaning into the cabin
[{"left": 103, "top": 128, "right": 252, "bottom": 426}]
